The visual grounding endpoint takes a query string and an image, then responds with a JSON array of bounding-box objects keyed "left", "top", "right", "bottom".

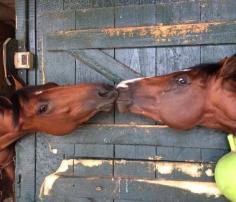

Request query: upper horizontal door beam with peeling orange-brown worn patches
[{"left": 47, "top": 21, "right": 236, "bottom": 51}]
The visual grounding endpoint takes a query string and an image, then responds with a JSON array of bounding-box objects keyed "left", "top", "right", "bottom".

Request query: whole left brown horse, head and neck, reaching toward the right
[{"left": 0, "top": 83, "right": 118, "bottom": 201}]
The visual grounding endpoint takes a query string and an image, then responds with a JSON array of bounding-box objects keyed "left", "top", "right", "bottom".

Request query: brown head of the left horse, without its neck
[{"left": 16, "top": 84, "right": 117, "bottom": 135}]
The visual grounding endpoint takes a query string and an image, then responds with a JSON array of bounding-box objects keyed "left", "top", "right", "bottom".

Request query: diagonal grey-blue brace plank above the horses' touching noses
[{"left": 67, "top": 49, "right": 142, "bottom": 82}]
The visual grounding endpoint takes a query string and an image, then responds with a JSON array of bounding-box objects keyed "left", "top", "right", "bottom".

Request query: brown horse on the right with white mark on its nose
[{"left": 117, "top": 54, "right": 236, "bottom": 133}]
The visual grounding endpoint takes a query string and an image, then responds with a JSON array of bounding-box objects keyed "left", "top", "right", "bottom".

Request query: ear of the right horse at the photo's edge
[{"left": 218, "top": 54, "right": 236, "bottom": 79}]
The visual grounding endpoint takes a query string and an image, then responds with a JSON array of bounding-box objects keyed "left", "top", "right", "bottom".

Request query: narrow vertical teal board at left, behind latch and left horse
[{"left": 15, "top": 0, "right": 36, "bottom": 202}]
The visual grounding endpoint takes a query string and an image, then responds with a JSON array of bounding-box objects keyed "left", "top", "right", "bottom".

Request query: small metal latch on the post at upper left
[{"left": 14, "top": 52, "right": 34, "bottom": 69}]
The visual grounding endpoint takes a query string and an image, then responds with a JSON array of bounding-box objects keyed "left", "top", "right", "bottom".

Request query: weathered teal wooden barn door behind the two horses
[{"left": 16, "top": 0, "right": 236, "bottom": 202}]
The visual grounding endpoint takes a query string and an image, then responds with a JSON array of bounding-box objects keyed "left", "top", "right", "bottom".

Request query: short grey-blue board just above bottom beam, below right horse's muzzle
[{"left": 114, "top": 160, "right": 156, "bottom": 178}]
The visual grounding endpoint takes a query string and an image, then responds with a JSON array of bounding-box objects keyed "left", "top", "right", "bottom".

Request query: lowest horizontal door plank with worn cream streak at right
[{"left": 40, "top": 177, "right": 227, "bottom": 202}]
